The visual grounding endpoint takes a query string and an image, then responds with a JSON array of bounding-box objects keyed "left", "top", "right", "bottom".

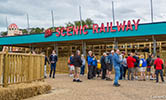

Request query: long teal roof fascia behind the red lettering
[{"left": 0, "top": 22, "right": 166, "bottom": 46}]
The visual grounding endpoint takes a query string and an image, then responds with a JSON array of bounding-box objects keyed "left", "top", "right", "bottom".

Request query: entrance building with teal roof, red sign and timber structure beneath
[{"left": 0, "top": 20, "right": 166, "bottom": 72}]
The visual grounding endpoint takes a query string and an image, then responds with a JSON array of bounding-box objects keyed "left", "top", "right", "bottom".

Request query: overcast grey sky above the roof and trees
[{"left": 0, "top": 0, "right": 166, "bottom": 31}]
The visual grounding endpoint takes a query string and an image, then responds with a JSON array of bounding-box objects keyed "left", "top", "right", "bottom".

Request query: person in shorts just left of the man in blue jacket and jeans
[{"left": 105, "top": 53, "right": 112, "bottom": 81}]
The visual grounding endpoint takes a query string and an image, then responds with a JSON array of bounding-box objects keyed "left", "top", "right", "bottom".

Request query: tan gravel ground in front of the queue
[{"left": 26, "top": 74, "right": 166, "bottom": 100}]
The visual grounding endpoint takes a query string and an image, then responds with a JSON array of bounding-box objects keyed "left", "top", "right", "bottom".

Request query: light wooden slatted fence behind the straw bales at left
[{"left": 0, "top": 52, "right": 44, "bottom": 87}]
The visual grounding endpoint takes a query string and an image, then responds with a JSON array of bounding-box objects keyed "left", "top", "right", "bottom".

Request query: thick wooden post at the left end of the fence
[{"left": 3, "top": 51, "right": 9, "bottom": 87}]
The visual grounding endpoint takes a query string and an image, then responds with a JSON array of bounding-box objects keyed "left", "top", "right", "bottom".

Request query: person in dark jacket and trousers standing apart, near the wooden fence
[{"left": 50, "top": 50, "right": 58, "bottom": 78}]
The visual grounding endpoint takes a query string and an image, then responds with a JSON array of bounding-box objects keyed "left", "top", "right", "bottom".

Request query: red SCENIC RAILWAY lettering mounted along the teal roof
[{"left": 45, "top": 19, "right": 140, "bottom": 37}]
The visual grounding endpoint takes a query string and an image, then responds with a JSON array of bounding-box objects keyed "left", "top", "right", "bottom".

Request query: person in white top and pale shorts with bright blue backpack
[{"left": 139, "top": 55, "right": 147, "bottom": 81}]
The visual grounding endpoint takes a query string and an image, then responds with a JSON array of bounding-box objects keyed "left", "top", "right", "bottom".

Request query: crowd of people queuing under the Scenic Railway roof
[{"left": 45, "top": 49, "right": 164, "bottom": 87}]
